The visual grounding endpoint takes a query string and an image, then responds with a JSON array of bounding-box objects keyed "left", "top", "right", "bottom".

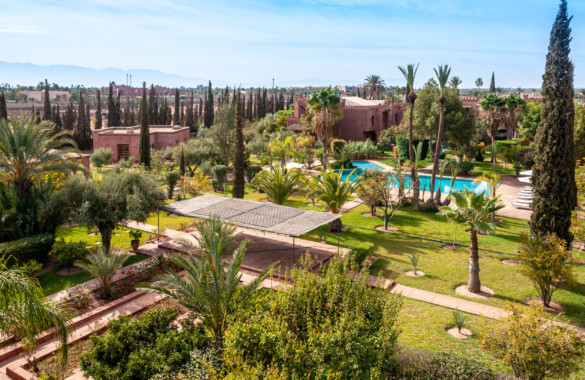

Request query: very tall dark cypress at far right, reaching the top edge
[{"left": 530, "top": 0, "right": 577, "bottom": 243}]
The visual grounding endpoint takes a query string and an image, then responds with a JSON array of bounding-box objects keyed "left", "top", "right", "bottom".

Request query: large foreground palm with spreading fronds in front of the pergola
[{"left": 142, "top": 217, "right": 272, "bottom": 347}]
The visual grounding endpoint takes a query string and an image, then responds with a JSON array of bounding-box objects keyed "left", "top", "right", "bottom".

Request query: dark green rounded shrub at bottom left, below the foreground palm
[{"left": 80, "top": 308, "right": 209, "bottom": 380}]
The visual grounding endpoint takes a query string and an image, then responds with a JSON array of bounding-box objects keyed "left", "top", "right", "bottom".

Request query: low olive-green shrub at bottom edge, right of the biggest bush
[{"left": 396, "top": 346, "right": 502, "bottom": 380}]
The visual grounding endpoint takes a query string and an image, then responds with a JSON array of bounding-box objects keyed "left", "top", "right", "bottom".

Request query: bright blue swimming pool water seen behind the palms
[{"left": 341, "top": 161, "right": 490, "bottom": 195}]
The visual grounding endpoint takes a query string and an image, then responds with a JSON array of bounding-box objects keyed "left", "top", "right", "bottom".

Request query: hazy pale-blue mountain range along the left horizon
[{"left": 0, "top": 61, "right": 217, "bottom": 87}]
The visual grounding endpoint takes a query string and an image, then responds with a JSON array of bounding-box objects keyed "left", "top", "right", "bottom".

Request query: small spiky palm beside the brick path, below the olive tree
[{"left": 75, "top": 247, "right": 130, "bottom": 299}]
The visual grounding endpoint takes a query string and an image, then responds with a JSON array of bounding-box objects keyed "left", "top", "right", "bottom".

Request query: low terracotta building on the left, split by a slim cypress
[{"left": 93, "top": 125, "right": 189, "bottom": 162}]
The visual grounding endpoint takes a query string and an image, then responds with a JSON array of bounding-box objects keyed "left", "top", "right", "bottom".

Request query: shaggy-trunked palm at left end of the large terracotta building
[{"left": 307, "top": 86, "right": 343, "bottom": 170}]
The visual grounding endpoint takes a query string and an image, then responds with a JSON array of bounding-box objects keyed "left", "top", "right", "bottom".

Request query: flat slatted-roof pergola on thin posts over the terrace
[{"left": 159, "top": 194, "right": 340, "bottom": 262}]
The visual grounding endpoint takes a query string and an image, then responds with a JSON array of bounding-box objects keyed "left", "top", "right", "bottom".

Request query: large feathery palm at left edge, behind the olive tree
[{"left": 0, "top": 117, "right": 85, "bottom": 198}]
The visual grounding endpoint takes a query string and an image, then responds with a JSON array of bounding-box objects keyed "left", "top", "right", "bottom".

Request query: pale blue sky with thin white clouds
[{"left": 0, "top": 0, "right": 585, "bottom": 88}]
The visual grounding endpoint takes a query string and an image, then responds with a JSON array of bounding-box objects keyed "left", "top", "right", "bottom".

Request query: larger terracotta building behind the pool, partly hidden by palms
[{"left": 288, "top": 95, "right": 408, "bottom": 142}]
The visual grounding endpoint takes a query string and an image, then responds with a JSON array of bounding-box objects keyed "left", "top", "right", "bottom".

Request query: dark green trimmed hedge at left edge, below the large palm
[{"left": 0, "top": 234, "right": 55, "bottom": 265}]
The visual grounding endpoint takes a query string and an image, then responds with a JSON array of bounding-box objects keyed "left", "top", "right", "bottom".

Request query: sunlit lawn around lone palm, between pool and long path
[{"left": 302, "top": 205, "right": 585, "bottom": 326}]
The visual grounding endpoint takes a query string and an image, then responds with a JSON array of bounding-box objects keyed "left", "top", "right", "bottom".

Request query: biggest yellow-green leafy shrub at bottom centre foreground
[{"left": 224, "top": 257, "right": 401, "bottom": 379}]
